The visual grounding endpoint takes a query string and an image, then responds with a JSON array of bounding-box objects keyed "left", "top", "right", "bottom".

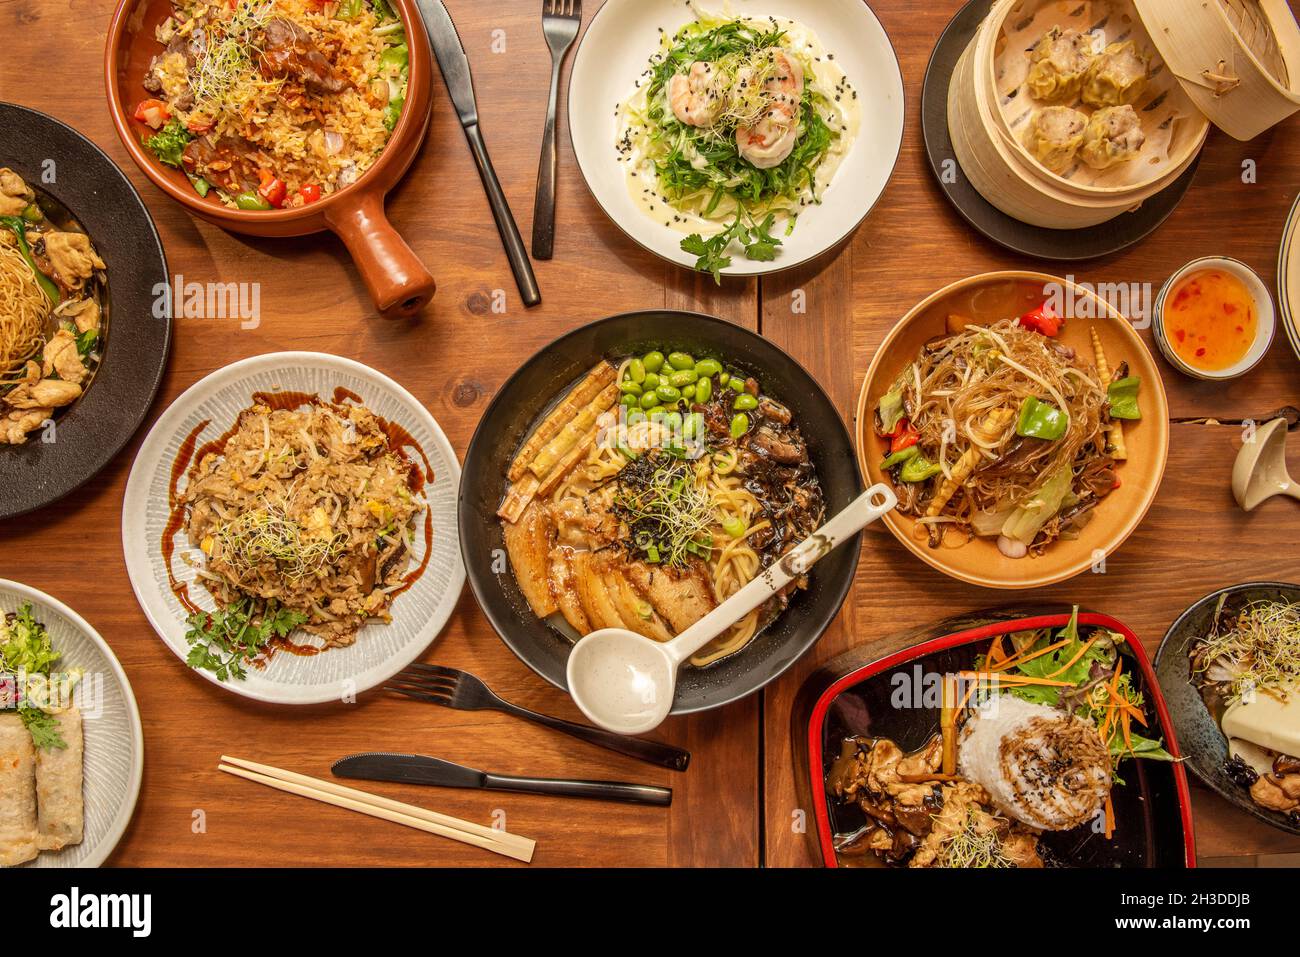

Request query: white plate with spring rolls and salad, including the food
[{"left": 0, "top": 579, "right": 144, "bottom": 867}]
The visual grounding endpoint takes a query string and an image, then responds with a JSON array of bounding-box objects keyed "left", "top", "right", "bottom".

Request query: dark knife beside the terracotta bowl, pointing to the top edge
[{"left": 417, "top": 0, "right": 542, "bottom": 306}]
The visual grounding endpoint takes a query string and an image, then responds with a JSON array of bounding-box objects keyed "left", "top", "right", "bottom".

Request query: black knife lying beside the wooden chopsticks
[{"left": 330, "top": 752, "right": 672, "bottom": 807}]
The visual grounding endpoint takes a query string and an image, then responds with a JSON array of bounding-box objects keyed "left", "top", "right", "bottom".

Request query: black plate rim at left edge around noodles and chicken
[{"left": 0, "top": 103, "right": 172, "bottom": 520}]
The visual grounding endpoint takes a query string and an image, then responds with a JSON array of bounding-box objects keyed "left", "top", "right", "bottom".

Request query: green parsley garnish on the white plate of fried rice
[{"left": 185, "top": 598, "right": 307, "bottom": 681}]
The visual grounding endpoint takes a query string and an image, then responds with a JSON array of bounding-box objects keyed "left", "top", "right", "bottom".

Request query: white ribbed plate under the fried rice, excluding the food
[{"left": 122, "top": 352, "right": 465, "bottom": 705}]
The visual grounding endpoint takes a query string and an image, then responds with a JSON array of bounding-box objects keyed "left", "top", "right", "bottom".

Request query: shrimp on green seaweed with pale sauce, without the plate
[{"left": 618, "top": 8, "right": 857, "bottom": 280}]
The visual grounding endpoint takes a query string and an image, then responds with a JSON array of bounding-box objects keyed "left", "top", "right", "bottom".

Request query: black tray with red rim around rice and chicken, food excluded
[{"left": 792, "top": 605, "right": 1196, "bottom": 867}]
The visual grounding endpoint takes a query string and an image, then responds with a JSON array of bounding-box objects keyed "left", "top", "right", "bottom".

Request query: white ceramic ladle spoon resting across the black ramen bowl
[{"left": 567, "top": 485, "right": 898, "bottom": 735}]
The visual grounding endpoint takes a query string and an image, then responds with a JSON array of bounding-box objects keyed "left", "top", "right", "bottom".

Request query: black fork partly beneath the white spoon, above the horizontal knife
[{"left": 384, "top": 664, "right": 690, "bottom": 771}]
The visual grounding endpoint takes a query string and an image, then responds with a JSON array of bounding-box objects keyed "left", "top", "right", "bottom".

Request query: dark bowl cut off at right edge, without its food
[{"left": 1156, "top": 581, "right": 1300, "bottom": 833}]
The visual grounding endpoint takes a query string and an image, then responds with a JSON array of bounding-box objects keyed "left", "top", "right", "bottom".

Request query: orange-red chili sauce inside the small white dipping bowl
[{"left": 1165, "top": 268, "right": 1260, "bottom": 372}]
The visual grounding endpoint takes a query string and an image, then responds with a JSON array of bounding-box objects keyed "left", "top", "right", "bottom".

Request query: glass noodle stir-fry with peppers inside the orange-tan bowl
[{"left": 875, "top": 303, "right": 1141, "bottom": 558}]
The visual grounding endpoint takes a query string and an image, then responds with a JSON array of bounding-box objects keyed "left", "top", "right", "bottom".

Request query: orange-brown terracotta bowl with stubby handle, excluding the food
[{"left": 104, "top": 0, "right": 434, "bottom": 316}]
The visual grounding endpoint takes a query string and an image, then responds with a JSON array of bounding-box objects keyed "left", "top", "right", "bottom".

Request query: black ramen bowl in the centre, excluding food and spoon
[{"left": 459, "top": 309, "right": 863, "bottom": 714}]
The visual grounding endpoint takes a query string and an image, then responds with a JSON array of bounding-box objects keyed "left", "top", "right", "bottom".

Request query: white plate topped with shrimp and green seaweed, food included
[{"left": 568, "top": 0, "right": 904, "bottom": 280}]
